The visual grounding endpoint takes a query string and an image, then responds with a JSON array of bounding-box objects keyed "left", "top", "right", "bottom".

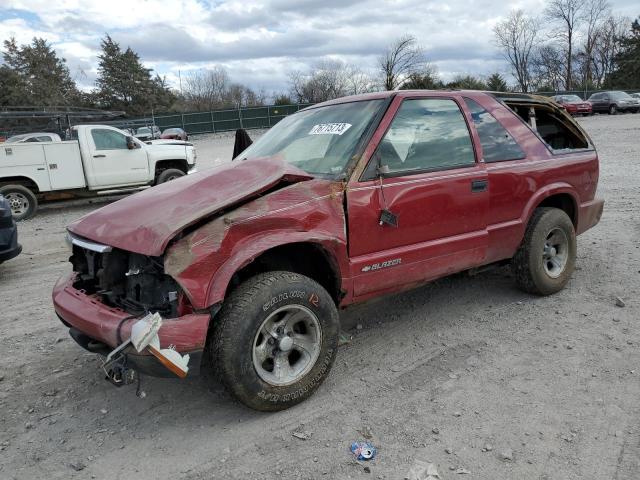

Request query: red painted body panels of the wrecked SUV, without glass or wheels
[{"left": 53, "top": 91, "right": 603, "bottom": 360}]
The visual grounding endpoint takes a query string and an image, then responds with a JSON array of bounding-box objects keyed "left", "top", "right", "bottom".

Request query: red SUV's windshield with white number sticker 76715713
[{"left": 239, "top": 100, "right": 384, "bottom": 177}]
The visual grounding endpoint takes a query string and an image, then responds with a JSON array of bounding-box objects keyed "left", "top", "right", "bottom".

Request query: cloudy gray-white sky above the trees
[{"left": 0, "top": 0, "right": 640, "bottom": 92}]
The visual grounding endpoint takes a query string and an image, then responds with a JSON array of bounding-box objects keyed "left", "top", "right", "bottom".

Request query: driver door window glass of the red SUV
[{"left": 377, "top": 98, "right": 475, "bottom": 173}]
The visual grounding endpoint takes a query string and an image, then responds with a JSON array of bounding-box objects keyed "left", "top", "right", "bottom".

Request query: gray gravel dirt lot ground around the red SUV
[{"left": 0, "top": 115, "right": 640, "bottom": 480}]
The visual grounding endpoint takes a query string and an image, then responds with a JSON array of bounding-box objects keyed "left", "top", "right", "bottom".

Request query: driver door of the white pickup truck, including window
[{"left": 87, "top": 127, "right": 151, "bottom": 187}]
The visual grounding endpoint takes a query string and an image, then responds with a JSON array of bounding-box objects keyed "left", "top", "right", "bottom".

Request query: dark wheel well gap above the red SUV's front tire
[{"left": 225, "top": 243, "right": 343, "bottom": 305}]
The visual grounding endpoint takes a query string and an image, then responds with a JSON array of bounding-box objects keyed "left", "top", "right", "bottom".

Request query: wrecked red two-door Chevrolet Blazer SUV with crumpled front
[{"left": 53, "top": 91, "right": 603, "bottom": 410}]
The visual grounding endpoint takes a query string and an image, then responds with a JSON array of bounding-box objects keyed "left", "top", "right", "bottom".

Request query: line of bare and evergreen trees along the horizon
[{"left": 0, "top": 7, "right": 640, "bottom": 116}]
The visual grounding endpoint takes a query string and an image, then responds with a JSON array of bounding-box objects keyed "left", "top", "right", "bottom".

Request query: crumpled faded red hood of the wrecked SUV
[{"left": 68, "top": 158, "right": 313, "bottom": 256}]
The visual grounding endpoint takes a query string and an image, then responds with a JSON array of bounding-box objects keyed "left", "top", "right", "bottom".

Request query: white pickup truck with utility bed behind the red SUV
[{"left": 0, "top": 125, "right": 196, "bottom": 220}]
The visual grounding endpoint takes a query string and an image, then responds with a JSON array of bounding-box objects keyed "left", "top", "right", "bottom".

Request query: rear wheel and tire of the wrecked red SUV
[{"left": 511, "top": 207, "right": 576, "bottom": 295}]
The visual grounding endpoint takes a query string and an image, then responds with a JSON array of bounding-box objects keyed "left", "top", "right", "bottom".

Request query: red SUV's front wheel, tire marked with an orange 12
[{"left": 209, "top": 272, "right": 339, "bottom": 412}]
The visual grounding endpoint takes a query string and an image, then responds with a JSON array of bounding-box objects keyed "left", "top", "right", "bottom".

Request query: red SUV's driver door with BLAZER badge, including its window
[{"left": 347, "top": 97, "right": 489, "bottom": 297}]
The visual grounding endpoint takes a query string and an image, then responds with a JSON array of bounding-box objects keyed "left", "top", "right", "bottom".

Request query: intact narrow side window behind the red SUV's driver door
[{"left": 464, "top": 98, "right": 526, "bottom": 162}]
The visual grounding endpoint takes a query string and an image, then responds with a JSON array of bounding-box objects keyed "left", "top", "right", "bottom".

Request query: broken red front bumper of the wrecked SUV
[{"left": 52, "top": 273, "right": 211, "bottom": 377}]
